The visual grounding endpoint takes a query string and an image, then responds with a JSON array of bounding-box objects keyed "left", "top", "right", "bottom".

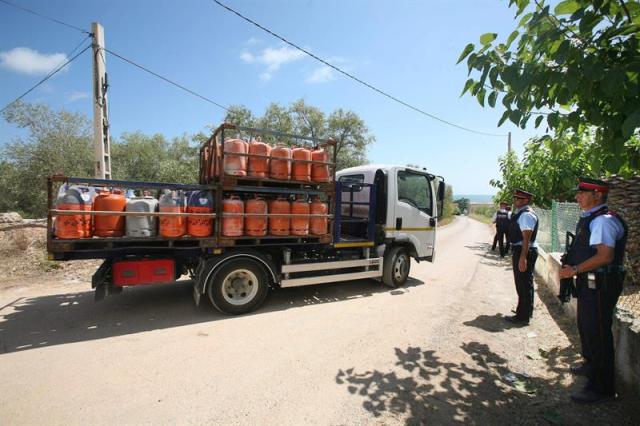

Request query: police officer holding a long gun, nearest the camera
[{"left": 560, "top": 178, "right": 627, "bottom": 403}]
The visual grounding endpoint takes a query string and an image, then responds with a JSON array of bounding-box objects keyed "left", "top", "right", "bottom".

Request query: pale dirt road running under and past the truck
[{"left": 0, "top": 218, "right": 640, "bottom": 425}]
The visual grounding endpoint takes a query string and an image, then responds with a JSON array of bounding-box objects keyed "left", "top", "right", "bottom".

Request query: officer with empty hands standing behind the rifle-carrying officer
[{"left": 505, "top": 189, "right": 538, "bottom": 325}]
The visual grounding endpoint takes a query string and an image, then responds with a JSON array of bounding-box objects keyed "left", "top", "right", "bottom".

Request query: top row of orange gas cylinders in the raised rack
[{"left": 222, "top": 139, "right": 331, "bottom": 183}]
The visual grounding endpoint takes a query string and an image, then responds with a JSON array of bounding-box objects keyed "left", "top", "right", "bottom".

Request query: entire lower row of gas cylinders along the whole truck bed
[{"left": 55, "top": 186, "right": 329, "bottom": 239}]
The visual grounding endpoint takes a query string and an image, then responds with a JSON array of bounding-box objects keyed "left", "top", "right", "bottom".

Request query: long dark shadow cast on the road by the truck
[{"left": 0, "top": 278, "right": 424, "bottom": 354}]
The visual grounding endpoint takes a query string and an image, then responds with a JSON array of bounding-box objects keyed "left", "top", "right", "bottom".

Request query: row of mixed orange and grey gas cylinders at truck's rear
[{"left": 55, "top": 185, "right": 213, "bottom": 239}]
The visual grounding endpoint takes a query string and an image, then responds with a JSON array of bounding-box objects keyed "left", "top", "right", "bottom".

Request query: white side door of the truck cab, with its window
[{"left": 387, "top": 170, "right": 436, "bottom": 259}]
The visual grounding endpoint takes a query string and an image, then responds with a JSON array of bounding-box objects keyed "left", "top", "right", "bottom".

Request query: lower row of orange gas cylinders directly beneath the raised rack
[{"left": 221, "top": 194, "right": 329, "bottom": 237}]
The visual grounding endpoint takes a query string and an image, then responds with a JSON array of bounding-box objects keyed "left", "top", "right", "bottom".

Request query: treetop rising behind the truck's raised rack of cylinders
[{"left": 225, "top": 99, "right": 375, "bottom": 170}]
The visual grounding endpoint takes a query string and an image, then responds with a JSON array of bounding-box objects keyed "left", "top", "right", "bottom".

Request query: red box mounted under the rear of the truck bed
[{"left": 113, "top": 259, "right": 176, "bottom": 287}]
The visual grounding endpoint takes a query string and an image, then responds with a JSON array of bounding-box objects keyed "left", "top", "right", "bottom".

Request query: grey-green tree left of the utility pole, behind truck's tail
[{"left": 0, "top": 102, "right": 94, "bottom": 217}]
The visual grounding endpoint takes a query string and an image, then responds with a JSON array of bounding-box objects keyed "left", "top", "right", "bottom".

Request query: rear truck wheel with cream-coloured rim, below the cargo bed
[{"left": 206, "top": 258, "right": 269, "bottom": 315}]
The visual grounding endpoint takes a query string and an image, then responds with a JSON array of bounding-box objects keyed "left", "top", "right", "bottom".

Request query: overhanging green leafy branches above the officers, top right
[{"left": 458, "top": 0, "right": 640, "bottom": 174}]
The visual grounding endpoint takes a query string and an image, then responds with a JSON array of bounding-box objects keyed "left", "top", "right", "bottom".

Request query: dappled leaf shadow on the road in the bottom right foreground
[{"left": 335, "top": 342, "right": 638, "bottom": 425}]
